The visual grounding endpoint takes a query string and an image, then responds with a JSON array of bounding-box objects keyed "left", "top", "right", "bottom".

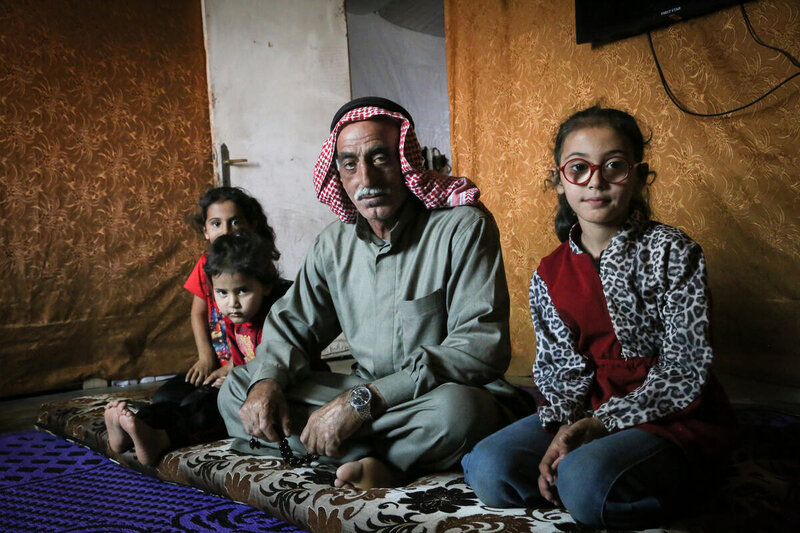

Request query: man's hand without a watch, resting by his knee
[{"left": 239, "top": 379, "right": 291, "bottom": 442}]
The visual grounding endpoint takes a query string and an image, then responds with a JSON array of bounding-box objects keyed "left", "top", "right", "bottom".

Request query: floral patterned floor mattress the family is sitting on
[{"left": 37, "top": 391, "right": 800, "bottom": 533}]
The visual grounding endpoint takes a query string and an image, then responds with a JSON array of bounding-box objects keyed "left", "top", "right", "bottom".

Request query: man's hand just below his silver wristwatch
[{"left": 300, "top": 389, "right": 366, "bottom": 458}]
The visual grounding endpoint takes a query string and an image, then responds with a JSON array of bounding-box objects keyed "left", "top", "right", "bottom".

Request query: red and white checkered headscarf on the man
[{"left": 314, "top": 106, "right": 485, "bottom": 224}]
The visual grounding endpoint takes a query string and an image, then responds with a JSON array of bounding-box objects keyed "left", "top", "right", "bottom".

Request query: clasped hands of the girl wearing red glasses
[{"left": 539, "top": 417, "right": 608, "bottom": 505}]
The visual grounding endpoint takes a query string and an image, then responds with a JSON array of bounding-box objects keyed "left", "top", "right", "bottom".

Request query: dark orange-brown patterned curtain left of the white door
[{"left": 0, "top": 0, "right": 213, "bottom": 396}]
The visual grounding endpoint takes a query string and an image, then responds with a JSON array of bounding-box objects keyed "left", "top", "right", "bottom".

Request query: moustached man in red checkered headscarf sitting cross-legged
[{"left": 219, "top": 97, "right": 513, "bottom": 488}]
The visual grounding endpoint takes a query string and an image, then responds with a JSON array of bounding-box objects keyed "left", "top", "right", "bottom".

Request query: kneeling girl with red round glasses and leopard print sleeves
[{"left": 462, "top": 107, "right": 734, "bottom": 528}]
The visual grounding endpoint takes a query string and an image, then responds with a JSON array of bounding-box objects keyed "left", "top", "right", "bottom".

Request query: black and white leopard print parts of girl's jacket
[{"left": 529, "top": 214, "right": 712, "bottom": 431}]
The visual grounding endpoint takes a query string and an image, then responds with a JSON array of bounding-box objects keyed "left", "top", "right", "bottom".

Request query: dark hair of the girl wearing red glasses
[{"left": 550, "top": 105, "right": 655, "bottom": 242}]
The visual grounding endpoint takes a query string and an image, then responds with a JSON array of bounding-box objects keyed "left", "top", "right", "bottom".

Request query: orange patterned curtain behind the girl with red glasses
[{"left": 445, "top": 0, "right": 800, "bottom": 386}]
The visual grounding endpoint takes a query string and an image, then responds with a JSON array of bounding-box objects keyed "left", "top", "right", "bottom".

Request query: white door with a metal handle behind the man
[{"left": 203, "top": 0, "right": 350, "bottom": 279}]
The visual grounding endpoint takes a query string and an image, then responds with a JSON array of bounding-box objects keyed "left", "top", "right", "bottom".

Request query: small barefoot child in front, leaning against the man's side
[{"left": 105, "top": 202, "right": 291, "bottom": 464}]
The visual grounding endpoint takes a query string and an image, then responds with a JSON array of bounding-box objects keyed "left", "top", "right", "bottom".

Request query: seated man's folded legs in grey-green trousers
[{"left": 218, "top": 365, "right": 511, "bottom": 472}]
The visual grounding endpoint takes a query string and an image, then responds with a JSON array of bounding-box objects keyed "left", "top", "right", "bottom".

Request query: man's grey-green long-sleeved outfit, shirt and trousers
[{"left": 219, "top": 199, "right": 513, "bottom": 470}]
